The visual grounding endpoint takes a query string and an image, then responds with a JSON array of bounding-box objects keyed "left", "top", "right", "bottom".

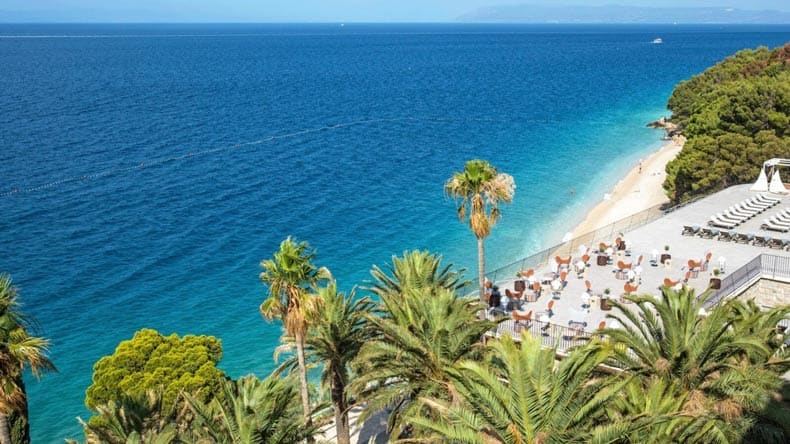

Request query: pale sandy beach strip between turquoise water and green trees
[{"left": 573, "top": 138, "right": 685, "bottom": 237}]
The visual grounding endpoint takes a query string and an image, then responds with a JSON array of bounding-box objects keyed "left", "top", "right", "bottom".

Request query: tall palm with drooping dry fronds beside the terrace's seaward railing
[{"left": 444, "top": 159, "right": 516, "bottom": 299}]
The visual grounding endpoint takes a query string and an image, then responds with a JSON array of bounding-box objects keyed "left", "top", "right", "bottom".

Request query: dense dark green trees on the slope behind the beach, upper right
[{"left": 664, "top": 44, "right": 790, "bottom": 202}]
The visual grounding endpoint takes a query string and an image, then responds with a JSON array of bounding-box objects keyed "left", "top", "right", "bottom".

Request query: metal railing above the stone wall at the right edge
[{"left": 705, "top": 253, "right": 790, "bottom": 308}]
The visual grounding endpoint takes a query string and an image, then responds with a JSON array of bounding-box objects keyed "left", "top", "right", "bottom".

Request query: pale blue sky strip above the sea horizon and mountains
[{"left": 0, "top": 0, "right": 790, "bottom": 22}]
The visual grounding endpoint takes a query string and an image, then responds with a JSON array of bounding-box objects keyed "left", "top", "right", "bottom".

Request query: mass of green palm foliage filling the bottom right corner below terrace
[{"left": 592, "top": 288, "right": 790, "bottom": 443}]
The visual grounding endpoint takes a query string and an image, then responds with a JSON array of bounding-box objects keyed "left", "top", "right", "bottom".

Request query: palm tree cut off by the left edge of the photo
[{"left": 0, "top": 274, "right": 55, "bottom": 444}]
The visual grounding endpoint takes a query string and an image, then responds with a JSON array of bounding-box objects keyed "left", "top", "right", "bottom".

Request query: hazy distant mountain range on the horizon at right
[{"left": 457, "top": 5, "right": 790, "bottom": 24}]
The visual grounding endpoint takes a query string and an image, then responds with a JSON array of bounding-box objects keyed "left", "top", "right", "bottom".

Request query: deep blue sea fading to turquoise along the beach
[{"left": 0, "top": 24, "right": 790, "bottom": 442}]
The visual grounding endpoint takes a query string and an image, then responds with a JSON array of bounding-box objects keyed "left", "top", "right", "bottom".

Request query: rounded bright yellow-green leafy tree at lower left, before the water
[{"left": 85, "top": 329, "right": 227, "bottom": 409}]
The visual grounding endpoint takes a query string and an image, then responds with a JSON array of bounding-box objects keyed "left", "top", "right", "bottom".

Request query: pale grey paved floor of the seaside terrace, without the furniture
[{"left": 488, "top": 185, "right": 790, "bottom": 332}]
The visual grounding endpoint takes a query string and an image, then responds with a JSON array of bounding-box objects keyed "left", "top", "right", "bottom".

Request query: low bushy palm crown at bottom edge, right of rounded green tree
[{"left": 185, "top": 375, "right": 315, "bottom": 444}]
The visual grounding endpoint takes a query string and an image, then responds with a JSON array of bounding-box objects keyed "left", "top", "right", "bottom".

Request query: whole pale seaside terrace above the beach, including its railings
[{"left": 488, "top": 185, "right": 790, "bottom": 351}]
